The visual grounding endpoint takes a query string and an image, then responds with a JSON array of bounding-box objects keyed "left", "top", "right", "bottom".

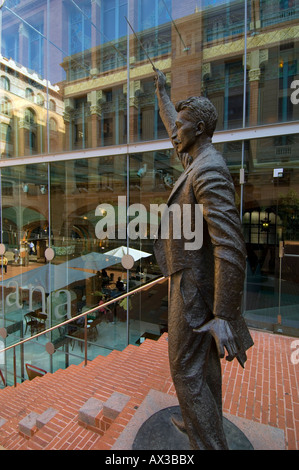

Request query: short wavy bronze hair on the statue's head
[{"left": 175, "top": 96, "right": 218, "bottom": 137}]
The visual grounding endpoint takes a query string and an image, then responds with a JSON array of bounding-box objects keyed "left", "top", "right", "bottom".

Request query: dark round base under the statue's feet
[{"left": 132, "top": 406, "right": 254, "bottom": 450}]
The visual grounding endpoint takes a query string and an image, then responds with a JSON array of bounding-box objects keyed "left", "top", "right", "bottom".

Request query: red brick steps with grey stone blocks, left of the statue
[{"left": 0, "top": 334, "right": 175, "bottom": 450}]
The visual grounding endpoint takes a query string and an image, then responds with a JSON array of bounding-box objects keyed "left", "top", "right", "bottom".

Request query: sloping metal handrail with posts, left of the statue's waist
[{"left": 0, "top": 276, "right": 167, "bottom": 386}]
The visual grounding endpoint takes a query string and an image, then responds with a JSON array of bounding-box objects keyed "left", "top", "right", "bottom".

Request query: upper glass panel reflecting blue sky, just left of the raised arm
[{"left": 49, "top": 0, "right": 127, "bottom": 152}]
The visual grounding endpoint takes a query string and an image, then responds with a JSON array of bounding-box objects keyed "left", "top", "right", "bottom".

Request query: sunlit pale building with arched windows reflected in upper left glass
[{"left": 0, "top": 56, "right": 65, "bottom": 159}]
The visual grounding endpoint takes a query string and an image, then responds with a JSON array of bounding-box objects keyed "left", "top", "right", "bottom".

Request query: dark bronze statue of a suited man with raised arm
[{"left": 154, "top": 70, "right": 253, "bottom": 449}]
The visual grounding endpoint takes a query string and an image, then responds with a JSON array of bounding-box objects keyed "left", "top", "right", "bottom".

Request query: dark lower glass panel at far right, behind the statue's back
[{"left": 243, "top": 134, "right": 299, "bottom": 328}]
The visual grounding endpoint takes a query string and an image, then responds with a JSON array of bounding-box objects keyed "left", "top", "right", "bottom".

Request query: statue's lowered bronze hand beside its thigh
[{"left": 194, "top": 317, "right": 242, "bottom": 361}]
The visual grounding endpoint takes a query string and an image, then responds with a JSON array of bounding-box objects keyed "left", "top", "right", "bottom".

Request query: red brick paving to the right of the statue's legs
[{"left": 222, "top": 331, "right": 299, "bottom": 450}]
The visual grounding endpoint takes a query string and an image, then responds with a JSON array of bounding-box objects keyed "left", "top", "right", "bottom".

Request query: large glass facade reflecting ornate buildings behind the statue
[{"left": 0, "top": 0, "right": 299, "bottom": 386}]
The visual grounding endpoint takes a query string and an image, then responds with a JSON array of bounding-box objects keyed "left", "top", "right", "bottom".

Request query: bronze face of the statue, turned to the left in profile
[{"left": 172, "top": 109, "right": 198, "bottom": 155}]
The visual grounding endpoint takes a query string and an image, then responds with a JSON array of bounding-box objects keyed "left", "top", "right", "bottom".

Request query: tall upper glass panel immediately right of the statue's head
[{"left": 201, "top": 1, "right": 250, "bottom": 130}]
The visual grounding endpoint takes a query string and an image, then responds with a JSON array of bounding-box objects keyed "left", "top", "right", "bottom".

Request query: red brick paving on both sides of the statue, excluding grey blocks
[{"left": 0, "top": 331, "right": 299, "bottom": 450}]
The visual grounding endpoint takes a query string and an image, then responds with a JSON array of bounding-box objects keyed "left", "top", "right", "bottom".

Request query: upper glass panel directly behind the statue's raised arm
[{"left": 128, "top": 0, "right": 201, "bottom": 141}]
